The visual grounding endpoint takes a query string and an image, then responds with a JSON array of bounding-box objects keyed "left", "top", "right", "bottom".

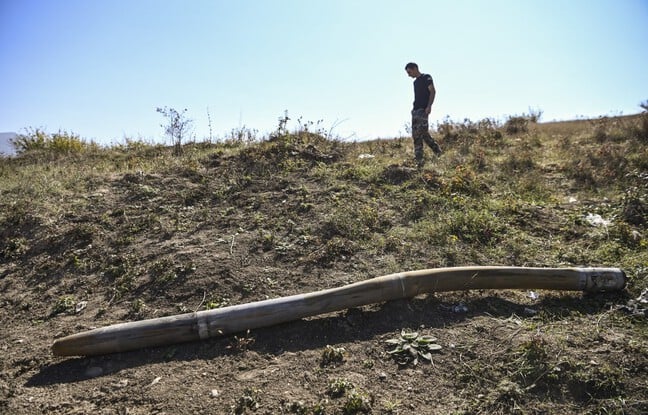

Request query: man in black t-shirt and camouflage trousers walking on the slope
[{"left": 405, "top": 62, "right": 442, "bottom": 167}]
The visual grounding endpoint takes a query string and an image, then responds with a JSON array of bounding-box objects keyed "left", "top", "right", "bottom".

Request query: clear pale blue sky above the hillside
[{"left": 0, "top": 0, "right": 648, "bottom": 144}]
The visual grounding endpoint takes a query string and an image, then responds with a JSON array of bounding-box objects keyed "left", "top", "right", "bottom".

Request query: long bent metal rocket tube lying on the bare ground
[{"left": 52, "top": 267, "right": 626, "bottom": 356}]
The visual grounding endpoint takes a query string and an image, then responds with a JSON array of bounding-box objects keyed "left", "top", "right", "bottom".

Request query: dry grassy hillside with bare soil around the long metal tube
[{"left": 0, "top": 114, "right": 648, "bottom": 414}]
